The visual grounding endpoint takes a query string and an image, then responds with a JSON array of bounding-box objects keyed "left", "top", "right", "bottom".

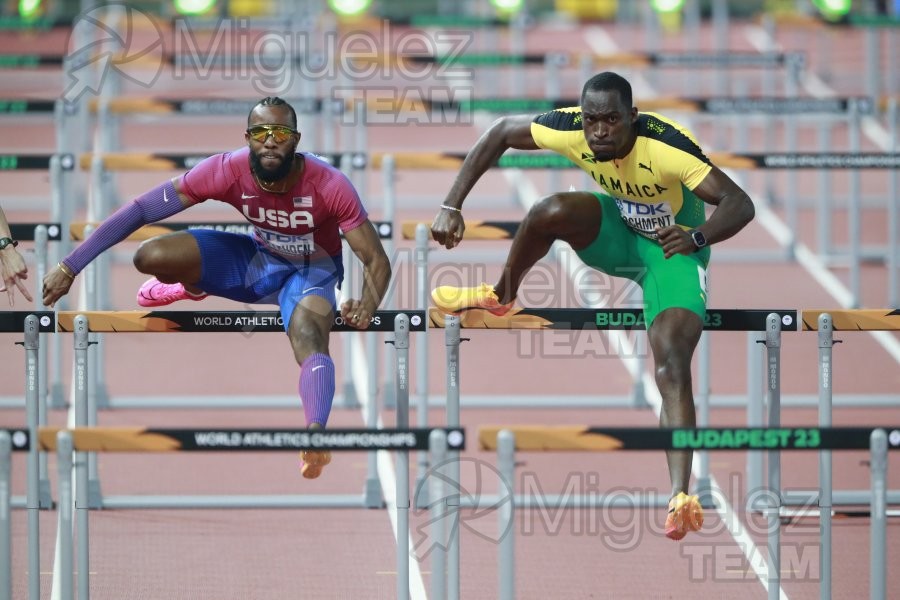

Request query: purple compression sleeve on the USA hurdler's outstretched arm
[{"left": 62, "top": 181, "right": 185, "bottom": 274}]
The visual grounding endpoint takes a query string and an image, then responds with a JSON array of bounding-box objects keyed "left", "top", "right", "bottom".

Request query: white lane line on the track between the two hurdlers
[{"left": 350, "top": 335, "right": 428, "bottom": 600}]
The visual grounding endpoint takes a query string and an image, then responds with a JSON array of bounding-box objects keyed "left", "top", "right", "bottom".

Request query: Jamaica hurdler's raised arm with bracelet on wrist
[{"left": 431, "top": 115, "right": 538, "bottom": 249}]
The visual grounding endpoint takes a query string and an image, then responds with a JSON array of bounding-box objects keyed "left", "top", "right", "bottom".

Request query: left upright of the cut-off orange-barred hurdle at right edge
[{"left": 818, "top": 313, "right": 834, "bottom": 598}]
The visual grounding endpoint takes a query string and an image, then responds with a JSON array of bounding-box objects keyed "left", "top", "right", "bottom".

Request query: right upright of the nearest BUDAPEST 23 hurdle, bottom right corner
[{"left": 869, "top": 429, "right": 887, "bottom": 600}]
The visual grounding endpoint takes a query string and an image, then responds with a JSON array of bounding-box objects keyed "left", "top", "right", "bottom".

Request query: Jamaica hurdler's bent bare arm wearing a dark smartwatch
[{"left": 659, "top": 165, "right": 756, "bottom": 258}]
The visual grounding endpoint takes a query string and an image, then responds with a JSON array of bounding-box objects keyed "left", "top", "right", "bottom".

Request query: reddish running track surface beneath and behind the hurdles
[{"left": 0, "top": 14, "right": 900, "bottom": 599}]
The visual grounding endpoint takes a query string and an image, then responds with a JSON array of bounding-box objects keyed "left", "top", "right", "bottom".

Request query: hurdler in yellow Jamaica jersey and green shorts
[{"left": 431, "top": 72, "right": 754, "bottom": 540}]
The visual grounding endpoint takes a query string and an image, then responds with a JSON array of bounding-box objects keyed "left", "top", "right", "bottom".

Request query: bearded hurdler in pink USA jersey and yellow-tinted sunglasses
[{"left": 43, "top": 97, "right": 391, "bottom": 479}]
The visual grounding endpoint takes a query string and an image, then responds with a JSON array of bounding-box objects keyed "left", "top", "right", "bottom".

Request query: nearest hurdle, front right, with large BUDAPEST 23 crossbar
[{"left": 474, "top": 426, "right": 900, "bottom": 600}]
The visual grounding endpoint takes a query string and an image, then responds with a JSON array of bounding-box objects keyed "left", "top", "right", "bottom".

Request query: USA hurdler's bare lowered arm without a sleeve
[{"left": 341, "top": 220, "right": 391, "bottom": 329}]
